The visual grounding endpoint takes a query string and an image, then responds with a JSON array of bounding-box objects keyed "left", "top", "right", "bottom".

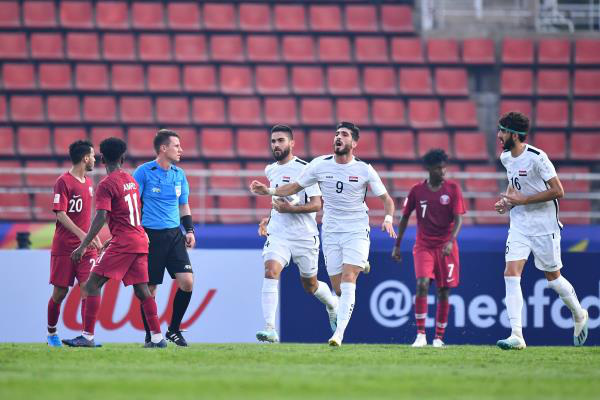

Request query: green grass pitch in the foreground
[{"left": 0, "top": 343, "right": 600, "bottom": 400}]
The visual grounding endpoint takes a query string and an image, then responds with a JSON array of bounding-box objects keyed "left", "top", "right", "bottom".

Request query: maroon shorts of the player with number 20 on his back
[{"left": 50, "top": 250, "right": 98, "bottom": 287}]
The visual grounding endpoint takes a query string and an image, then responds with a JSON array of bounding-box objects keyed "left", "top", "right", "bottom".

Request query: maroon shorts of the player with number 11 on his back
[{"left": 92, "top": 246, "right": 148, "bottom": 286}]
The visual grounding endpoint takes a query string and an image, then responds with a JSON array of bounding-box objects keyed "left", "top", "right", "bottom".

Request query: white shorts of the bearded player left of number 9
[{"left": 263, "top": 235, "right": 319, "bottom": 278}]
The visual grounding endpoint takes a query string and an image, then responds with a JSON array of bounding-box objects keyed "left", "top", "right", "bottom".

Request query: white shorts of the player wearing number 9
[{"left": 321, "top": 229, "right": 371, "bottom": 276}]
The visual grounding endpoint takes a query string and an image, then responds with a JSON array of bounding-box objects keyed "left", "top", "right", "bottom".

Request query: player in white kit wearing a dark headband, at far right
[{"left": 495, "top": 112, "right": 588, "bottom": 350}]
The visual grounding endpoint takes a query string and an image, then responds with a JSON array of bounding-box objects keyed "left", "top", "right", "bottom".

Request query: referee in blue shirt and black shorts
[{"left": 133, "top": 129, "right": 196, "bottom": 346}]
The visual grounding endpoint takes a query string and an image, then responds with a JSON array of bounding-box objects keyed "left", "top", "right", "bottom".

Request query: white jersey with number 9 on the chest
[{"left": 298, "top": 155, "right": 387, "bottom": 232}]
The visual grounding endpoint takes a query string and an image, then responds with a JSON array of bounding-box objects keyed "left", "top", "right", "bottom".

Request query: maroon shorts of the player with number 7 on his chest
[{"left": 413, "top": 241, "right": 460, "bottom": 288}]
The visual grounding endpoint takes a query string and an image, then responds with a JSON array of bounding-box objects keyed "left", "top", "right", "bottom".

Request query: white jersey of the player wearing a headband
[{"left": 500, "top": 144, "right": 562, "bottom": 236}]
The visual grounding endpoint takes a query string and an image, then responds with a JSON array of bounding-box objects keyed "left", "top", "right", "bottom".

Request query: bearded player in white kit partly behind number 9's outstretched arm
[{"left": 256, "top": 125, "right": 338, "bottom": 342}]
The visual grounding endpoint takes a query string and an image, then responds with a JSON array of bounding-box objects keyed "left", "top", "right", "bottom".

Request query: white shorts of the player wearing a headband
[{"left": 505, "top": 230, "right": 562, "bottom": 272}]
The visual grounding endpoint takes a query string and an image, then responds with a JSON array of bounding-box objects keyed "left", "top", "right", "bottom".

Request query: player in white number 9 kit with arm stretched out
[{"left": 250, "top": 122, "right": 396, "bottom": 346}]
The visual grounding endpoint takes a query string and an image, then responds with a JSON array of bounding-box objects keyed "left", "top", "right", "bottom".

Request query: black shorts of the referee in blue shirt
[{"left": 144, "top": 227, "right": 193, "bottom": 285}]
